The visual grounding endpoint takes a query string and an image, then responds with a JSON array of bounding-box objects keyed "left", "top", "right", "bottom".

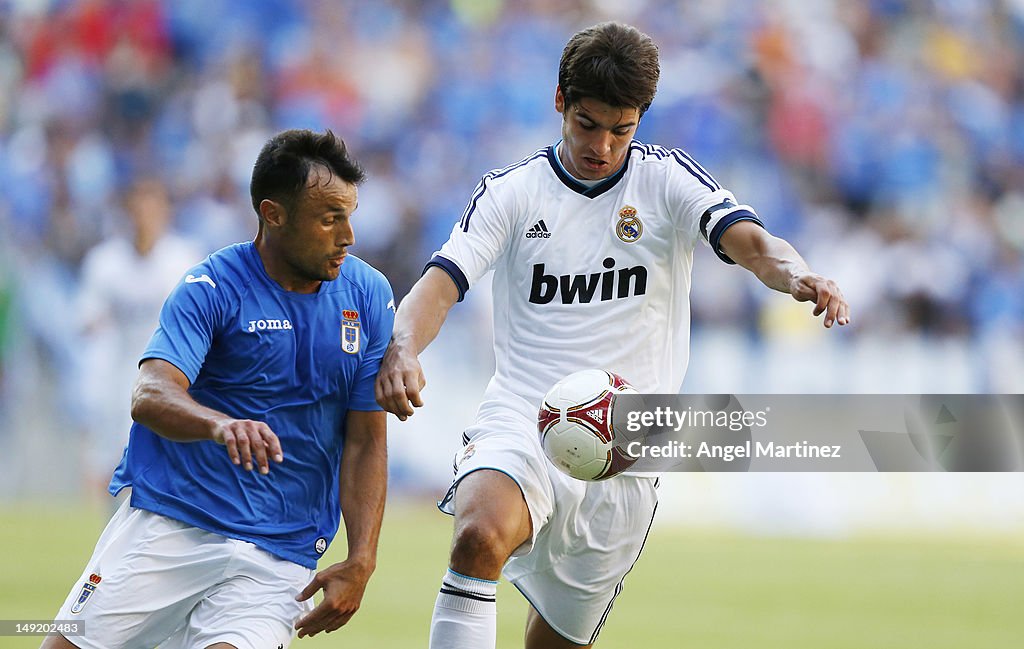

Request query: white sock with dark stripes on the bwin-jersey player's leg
[{"left": 430, "top": 568, "right": 498, "bottom": 649}]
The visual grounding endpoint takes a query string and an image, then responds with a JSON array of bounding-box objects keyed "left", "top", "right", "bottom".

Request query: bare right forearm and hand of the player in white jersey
[{"left": 720, "top": 221, "right": 850, "bottom": 327}]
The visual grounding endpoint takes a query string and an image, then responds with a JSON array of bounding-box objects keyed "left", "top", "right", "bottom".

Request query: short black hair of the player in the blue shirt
[{"left": 249, "top": 129, "right": 366, "bottom": 214}]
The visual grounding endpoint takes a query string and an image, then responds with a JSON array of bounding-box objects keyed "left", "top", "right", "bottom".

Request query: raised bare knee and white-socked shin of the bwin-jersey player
[{"left": 430, "top": 469, "right": 530, "bottom": 649}]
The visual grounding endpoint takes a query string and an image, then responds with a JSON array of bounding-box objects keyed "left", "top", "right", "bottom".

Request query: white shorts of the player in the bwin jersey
[{"left": 438, "top": 408, "right": 657, "bottom": 645}]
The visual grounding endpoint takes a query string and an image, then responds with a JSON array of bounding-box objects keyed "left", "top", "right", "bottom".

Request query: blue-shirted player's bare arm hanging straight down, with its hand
[{"left": 295, "top": 410, "right": 387, "bottom": 638}]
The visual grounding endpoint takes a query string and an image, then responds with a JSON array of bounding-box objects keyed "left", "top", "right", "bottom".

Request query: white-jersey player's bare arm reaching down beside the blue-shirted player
[{"left": 375, "top": 266, "right": 459, "bottom": 421}]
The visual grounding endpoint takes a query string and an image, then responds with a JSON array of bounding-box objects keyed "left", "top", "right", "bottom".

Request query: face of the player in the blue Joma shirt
[{"left": 281, "top": 167, "right": 358, "bottom": 289}]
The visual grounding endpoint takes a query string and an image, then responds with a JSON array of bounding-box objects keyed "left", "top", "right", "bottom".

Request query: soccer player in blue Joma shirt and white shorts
[{"left": 43, "top": 130, "right": 394, "bottom": 649}]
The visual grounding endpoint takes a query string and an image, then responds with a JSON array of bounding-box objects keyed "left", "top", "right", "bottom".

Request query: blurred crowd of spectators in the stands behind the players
[{"left": 0, "top": 0, "right": 1024, "bottom": 444}]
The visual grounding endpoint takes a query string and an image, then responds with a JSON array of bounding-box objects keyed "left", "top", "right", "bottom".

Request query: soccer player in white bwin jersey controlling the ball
[{"left": 377, "top": 23, "right": 850, "bottom": 649}]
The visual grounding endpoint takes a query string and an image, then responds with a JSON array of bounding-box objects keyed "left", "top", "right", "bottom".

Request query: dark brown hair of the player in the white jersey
[{"left": 558, "top": 23, "right": 660, "bottom": 115}]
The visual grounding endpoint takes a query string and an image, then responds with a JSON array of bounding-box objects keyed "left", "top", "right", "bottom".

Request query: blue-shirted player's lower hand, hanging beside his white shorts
[{"left": 295, "top": 560, "right": 373, "bottom": 638}]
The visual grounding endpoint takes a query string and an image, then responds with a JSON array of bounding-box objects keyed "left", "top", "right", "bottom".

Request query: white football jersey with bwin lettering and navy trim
[{"left": 428, "top": 140, "right": 760, "bottom": 412}]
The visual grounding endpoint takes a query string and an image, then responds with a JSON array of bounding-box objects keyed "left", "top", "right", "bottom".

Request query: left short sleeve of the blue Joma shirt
[{"left": 140, "top": 265, "right": 227, "bottom": 383}]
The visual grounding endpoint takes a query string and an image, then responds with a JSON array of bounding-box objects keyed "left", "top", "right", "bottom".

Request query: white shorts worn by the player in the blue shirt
[{"left": 56, "top": 501, "right": 314, "bottom": 649}]
